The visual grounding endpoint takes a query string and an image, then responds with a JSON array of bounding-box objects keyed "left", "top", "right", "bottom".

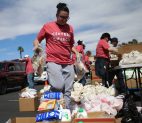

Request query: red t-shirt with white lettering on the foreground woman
[{"left": 37, "top": 22, "right": 74, "bottom": 64}]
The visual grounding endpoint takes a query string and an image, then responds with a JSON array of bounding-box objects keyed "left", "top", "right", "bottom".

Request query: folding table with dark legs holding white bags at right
[{"left": 113, "top": 63, "right": 142, "bottom": 106}]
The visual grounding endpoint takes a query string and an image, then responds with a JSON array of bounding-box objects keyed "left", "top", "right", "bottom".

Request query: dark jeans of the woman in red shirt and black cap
[{"left": 95, "top": 58, "right": 109, "bottom": 87}]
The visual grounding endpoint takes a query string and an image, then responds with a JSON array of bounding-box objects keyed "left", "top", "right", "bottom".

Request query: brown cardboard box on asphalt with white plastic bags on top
[{"left": 19, "top": 97, "right": 39, "bottom": 111}]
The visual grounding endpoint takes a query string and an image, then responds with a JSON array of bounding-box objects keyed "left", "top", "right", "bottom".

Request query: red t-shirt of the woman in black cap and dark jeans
[{"left": 96, "top": 39, "right": 109, "bottom": 58}]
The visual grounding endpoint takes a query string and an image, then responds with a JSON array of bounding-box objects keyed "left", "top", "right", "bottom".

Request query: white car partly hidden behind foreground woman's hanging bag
[{"left": 34, "top": 67, "right": 48, "bottom": 82}]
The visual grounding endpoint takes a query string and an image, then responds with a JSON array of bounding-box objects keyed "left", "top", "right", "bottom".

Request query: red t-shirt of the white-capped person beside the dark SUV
[{"left": 24, "top": 57, "right": 34, "bottom": 74}]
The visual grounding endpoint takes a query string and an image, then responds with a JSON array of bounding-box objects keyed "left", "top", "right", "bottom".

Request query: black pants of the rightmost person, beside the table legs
[{"left": 109, "top": 69, "right": 126, "bottom": 93}]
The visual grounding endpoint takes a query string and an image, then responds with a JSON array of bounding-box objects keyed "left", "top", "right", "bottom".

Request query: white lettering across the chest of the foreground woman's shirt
[{"left": 51, "top": 32, "right": 71, "bottom": 42}]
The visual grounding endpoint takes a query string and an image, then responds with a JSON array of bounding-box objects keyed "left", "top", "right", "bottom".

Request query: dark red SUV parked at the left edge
[{"left": 0, "top": 60, "right": 27, "bottom": 94}]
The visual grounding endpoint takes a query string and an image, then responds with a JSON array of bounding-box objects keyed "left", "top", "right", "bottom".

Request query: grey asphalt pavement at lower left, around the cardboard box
[{"left": 0, "top": 85, "right": 43, "bottom": 123}]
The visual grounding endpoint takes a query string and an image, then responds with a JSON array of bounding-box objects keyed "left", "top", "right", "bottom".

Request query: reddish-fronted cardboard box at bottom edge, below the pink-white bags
[{"left": 74, "top": 112, "right": 116, "bottom": 123}]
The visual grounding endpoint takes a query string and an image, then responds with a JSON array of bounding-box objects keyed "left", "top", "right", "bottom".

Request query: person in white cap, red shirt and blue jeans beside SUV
[{"left": 21, "top": 55, "right": 34, "bottom": 88}]
